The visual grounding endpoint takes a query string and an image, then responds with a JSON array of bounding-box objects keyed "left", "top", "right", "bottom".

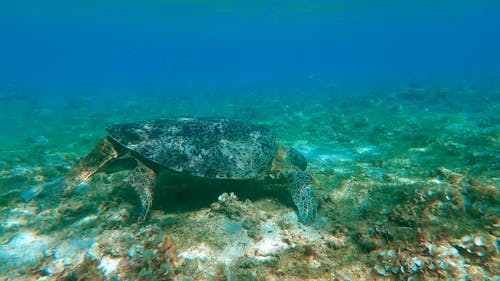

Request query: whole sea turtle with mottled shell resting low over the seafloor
[{"left": 65, "top": 118, "right": 318, "bottom": 224}]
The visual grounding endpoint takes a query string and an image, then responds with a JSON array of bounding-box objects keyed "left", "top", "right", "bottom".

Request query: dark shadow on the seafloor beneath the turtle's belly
[{"left": 153, "top": 172, "right": 294, "bottom": 213}]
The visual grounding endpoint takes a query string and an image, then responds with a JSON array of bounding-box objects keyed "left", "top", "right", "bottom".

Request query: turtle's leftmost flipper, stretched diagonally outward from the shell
[{"left": 64, "top": 138, "right": 121, "bottom": 196}]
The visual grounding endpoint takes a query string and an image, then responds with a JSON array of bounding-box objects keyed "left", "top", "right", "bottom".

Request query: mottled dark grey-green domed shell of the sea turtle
[{"left": 107, "top": 118, "right": 278, "bottom": 179}]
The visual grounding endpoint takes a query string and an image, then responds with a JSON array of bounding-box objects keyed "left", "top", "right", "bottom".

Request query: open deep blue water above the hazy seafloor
[{"left": 0, "top": 0, "right": 500, "bottom": 96}]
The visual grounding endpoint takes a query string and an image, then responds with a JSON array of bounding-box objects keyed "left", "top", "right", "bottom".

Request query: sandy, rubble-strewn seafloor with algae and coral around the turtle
[{"left": 0, "top": 83, "right": 500, "bottom": 280}]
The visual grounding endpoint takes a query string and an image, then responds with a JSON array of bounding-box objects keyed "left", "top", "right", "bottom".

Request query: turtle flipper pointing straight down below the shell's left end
[{"left": 127, "top": 161, "right": 156, "bottom": 224}]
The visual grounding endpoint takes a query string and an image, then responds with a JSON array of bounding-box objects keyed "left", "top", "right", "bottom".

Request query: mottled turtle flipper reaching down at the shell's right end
[{"left": 287, "top": 167, "right": 318, "bottom": 224}]
